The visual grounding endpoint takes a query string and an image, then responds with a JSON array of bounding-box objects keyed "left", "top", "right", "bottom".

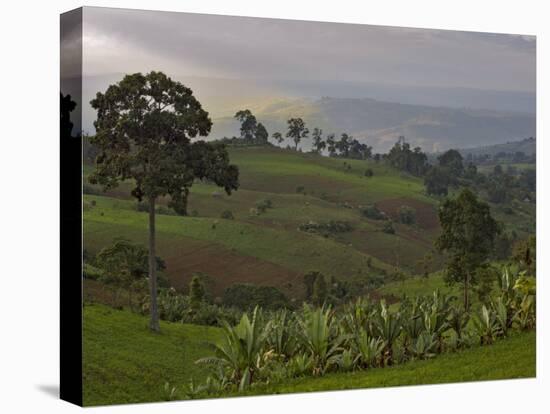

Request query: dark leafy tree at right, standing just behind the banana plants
[{"left": 436, "top": 188, "right": 500, "bottom": 310}]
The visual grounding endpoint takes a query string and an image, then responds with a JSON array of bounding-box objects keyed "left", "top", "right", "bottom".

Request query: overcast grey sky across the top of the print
[{"left": 83, "top": 8, "right": 536, "bottom": 92}]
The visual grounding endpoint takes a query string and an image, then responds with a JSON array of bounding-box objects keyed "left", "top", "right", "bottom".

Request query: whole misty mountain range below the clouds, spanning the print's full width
[{"left": 75, "top": 74, "right": 536, "bottom": 152}]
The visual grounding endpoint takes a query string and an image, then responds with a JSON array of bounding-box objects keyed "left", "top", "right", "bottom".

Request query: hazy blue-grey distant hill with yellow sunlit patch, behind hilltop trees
[{"left": 212, "top": 97, "right": 535, "bottom": 152}]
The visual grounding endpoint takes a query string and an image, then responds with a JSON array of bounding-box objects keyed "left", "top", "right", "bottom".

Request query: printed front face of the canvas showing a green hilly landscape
[{"left": 61, "top": 7, "right": 536, "bottom": 406}]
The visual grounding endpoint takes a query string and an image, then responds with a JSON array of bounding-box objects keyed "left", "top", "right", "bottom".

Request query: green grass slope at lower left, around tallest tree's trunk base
[{"left": 83, "top": 305, "right": 219, "bottom": 405}]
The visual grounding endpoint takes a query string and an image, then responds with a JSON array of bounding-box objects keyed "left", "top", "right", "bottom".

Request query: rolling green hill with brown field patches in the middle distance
[{"left": 84, "top": 147, "right": 444, "bottom": 298}]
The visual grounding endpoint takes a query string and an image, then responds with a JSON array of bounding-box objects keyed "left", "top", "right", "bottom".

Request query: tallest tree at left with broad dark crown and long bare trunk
[{"left": 89, "top": 72, "right": 239, "bottom": 331}]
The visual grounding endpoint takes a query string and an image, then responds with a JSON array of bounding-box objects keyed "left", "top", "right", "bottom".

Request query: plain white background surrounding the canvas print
[{"left": 0, "top": 0, "right": 550, "bottom": 414}]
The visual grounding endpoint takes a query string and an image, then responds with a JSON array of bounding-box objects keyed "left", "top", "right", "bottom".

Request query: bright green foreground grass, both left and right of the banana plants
[{"left": 83, "top": 304, "right": 536, "bottom": 406}]
